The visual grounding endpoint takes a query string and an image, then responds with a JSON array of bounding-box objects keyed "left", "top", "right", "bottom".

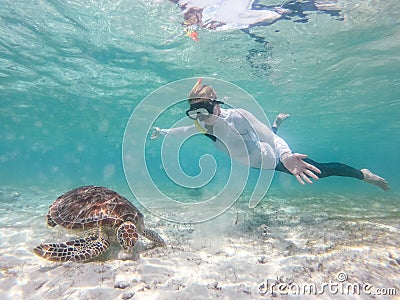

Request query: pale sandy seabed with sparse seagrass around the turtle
[{"left": 0, "top": 189, "right": 400, "bottom": 299}]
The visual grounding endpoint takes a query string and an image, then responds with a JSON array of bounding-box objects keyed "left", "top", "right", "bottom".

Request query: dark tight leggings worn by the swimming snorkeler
[{"left": 272, "top": 127, "right": 364, "bottom": 180}]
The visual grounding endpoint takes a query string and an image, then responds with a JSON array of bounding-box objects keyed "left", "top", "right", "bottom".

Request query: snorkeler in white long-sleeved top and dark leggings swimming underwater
[{"left": 151, "top": 79, "right": 389, "bottom": 190}]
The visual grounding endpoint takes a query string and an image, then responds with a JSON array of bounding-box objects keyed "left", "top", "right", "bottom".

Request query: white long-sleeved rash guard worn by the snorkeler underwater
[{"left": 160, "top": 108, "right": 291, "bottom": 170}]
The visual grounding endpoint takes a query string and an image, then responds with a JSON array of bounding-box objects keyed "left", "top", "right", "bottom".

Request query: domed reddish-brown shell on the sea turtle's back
[{"left": 47, "top": 186, "right": 143, "bottom": 230}]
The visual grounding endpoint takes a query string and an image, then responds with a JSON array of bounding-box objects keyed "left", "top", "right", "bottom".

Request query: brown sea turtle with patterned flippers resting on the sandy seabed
[{"left": 33, "top": 186, "right": 165, "bottom": 262}]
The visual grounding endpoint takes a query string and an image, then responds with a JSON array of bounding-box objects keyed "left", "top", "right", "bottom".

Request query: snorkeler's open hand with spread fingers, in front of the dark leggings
[{"left": 281, "top": 153, "right": 321, "bottom": 184}]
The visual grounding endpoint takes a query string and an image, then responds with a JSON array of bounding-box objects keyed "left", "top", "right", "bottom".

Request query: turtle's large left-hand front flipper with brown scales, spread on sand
[{"left": 33, "top": 235, "right": 110, "bottom": 262}]
